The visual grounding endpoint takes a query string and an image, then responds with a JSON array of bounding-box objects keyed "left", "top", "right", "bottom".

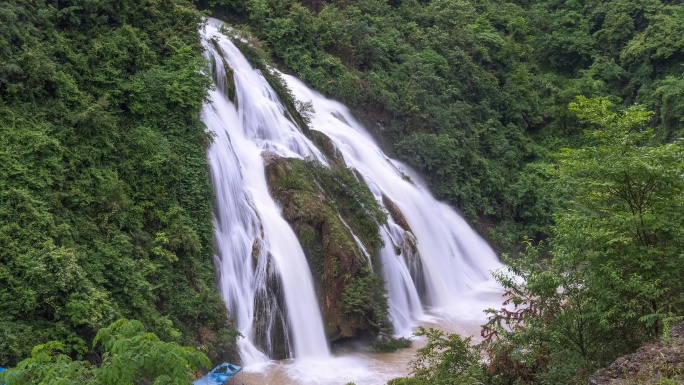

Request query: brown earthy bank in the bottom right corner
[{"left": 589, "top": 323, "right": 684, "bottom": 385}]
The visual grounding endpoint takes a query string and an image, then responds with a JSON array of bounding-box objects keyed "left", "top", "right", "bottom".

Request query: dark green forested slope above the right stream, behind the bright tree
[{"left": 206, "top": 0, "right": 684, "bottom": 249}]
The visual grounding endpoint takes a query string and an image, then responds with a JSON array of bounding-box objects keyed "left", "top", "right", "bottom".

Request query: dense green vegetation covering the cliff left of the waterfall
[{"left": 0, "top": 0, "right": 235, "bottom": 366}]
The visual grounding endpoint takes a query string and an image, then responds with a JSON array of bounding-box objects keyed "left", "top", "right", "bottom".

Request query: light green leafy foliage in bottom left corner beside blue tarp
[{"left": 0, "top": 319, "right": 211, "bottom": 385}]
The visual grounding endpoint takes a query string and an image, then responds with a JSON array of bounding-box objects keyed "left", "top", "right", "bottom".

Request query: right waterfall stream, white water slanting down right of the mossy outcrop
[{"left": 284, "top": 75, "right": 501, "bottom": 331}]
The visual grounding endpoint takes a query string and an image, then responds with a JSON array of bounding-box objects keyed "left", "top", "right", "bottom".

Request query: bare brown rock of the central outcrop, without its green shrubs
[{"left": 262, "top": 152, "right": 386, "bottom": 341}]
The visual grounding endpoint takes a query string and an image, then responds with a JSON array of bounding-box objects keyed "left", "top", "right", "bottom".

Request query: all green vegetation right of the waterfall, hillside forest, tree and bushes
[{"left": 202, "top": 0, "right": 684, "bottom": 384}]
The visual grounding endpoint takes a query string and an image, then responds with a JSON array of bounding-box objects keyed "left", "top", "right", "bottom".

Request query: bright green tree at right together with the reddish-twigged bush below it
[{"left": 483, "top": 97, "right": 684, "bottom": 384}]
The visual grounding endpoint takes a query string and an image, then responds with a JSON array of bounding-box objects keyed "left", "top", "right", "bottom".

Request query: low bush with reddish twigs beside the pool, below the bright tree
[{"left": 482, "top": 240, "right": 596, "bottom": 384}]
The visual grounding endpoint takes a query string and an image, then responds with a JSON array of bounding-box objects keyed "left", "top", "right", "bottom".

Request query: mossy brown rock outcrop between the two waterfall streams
[{"left": 263, "top": 153, "right": 390, "bottom": 341}]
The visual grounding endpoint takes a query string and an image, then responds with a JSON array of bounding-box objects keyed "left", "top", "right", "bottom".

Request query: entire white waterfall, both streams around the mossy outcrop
[{"left": 203, "top": 15, "right": 500, "bottom": 384}]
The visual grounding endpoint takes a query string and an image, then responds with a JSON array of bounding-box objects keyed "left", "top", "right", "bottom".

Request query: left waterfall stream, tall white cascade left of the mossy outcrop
[{"left": 203, "top": 20, "right": 329, "bottom": 365}]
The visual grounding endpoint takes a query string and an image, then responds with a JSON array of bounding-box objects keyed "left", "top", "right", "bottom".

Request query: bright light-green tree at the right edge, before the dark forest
[{"left": 555, "top": 97, "right": 684, "bottom": 335}]
